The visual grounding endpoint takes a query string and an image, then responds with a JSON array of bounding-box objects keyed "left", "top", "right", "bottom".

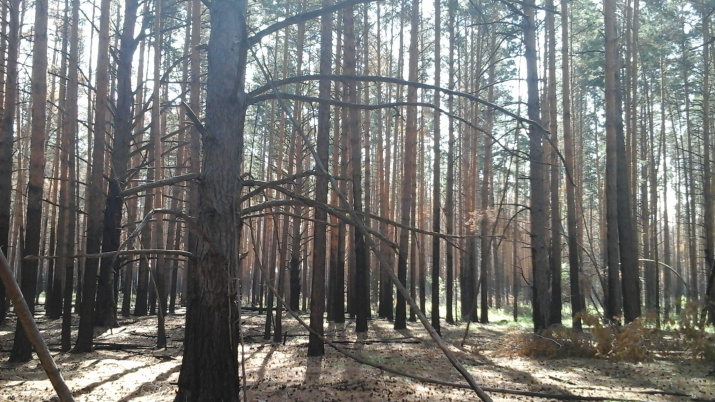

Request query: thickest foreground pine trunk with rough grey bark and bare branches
[{"left": 175, "top": 0, "right": 247, "bottom": 402}]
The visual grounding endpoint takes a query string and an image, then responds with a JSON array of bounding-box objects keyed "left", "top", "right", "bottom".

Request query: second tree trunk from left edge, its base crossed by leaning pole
[{"left": 10, "top": 0, "right": 48, "bottom": 362}]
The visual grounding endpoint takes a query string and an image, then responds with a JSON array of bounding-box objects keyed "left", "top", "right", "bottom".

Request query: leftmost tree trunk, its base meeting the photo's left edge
[{"left": 0, "top": 0, "right": 21, "bottom": 325}]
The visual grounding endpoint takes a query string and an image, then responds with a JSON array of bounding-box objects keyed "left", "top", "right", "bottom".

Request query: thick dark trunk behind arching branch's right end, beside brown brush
[{"left": 523, "top": 0, "right": 551, "bottom": 332}]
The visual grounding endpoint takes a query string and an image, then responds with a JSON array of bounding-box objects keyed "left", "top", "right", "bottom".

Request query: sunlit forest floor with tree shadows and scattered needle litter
[{"left": 0, "top": 310, "right": 715, "bottom": 402}]
